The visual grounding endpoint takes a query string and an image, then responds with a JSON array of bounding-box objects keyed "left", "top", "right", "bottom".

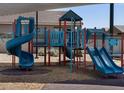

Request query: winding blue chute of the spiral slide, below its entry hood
[{"left": 6, "top": 32, "right": 34, "bottom": 69}]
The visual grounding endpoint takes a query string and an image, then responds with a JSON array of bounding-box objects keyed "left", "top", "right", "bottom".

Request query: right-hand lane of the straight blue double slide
[{"left": 99, "top": 48, "right": 123, "bottom": 74}]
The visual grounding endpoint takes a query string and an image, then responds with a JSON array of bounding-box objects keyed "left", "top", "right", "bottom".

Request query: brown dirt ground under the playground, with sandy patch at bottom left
[{"left": 0, "top": 54, "right": 124, "bottom": 89}]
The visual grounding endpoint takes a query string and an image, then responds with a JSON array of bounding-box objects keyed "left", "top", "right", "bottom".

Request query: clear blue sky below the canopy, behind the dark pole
[{"left": 50, "top": 3, "right": 124, "bottom": 28}]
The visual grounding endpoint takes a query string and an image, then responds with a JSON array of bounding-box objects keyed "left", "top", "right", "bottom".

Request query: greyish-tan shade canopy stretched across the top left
[{"left": 0, "top": 3, "right": 91, "bottom": 16}]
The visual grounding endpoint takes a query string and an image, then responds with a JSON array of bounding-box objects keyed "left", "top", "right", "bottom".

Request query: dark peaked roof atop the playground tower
[{"left": 59, "top": 10, "right": 82, "bottom": 21}]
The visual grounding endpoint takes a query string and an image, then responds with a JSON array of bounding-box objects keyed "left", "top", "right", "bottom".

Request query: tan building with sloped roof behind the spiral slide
[{"left": 0, "top": 11, "right": 65, "bottom": 53}]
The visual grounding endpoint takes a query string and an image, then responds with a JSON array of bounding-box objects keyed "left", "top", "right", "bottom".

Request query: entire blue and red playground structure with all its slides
[{"left": 6, "top": 11, "right": 124, "bottom": 74}]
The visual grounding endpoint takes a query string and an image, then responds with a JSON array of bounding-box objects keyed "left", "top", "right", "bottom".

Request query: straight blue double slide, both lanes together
[{"left": 87, "top": 47, "right": 123, "bottom": 74}]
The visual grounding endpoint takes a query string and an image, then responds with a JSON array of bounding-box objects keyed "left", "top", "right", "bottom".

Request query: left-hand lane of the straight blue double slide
[{"left": 87, "top": 47, "right": 114, "bottom": 74}]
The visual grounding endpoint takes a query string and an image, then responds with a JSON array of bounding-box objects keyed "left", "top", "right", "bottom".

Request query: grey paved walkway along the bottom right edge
[{"left": 42, "top": 84, "right": 124, "bottom": 90}]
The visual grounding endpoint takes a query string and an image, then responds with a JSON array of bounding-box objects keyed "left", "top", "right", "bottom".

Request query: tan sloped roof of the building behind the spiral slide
[{"left": 0, "top": 11, "right": 66, "bottom": 25}]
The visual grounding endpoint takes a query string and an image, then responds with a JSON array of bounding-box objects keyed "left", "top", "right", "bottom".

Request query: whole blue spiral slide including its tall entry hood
[{"left": 6, "top": 17, "right": 34, "bottom": 69}]
